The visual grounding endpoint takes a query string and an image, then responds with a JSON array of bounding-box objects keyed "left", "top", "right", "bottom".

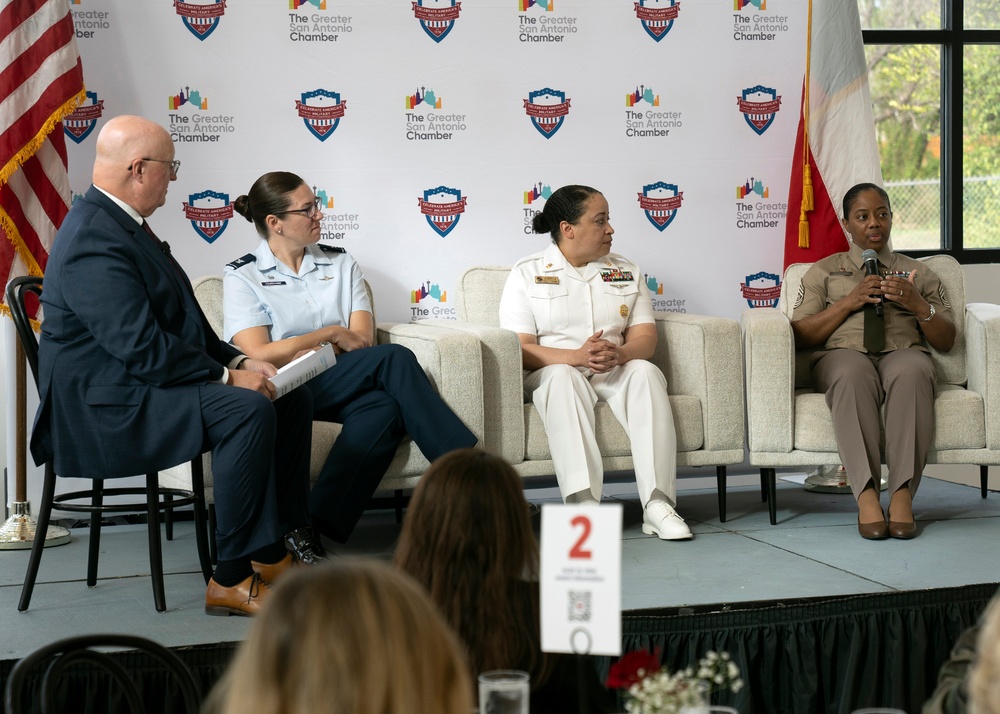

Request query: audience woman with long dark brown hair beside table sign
[{"left": 396, "top": 449, "right": 617, "bottom": 714}]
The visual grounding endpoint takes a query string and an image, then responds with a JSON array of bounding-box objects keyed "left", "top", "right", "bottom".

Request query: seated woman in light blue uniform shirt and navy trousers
[{"left": 223, "top": 171, "right": 476, "bottom": 543}]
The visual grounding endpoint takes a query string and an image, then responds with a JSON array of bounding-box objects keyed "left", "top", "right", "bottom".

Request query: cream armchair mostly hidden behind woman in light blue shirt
[{"left": 160, "top": 275, "right": 484, "bottom": 543}]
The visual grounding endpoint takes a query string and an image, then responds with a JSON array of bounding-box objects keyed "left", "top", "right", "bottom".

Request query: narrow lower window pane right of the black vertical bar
[{"left": 960, "top": 45, "right": 1000, "bottom": 248}]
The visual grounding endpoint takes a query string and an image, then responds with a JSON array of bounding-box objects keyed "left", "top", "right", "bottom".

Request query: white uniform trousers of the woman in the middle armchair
[{"left": 524, "top": 360, "right": 677, "bottom": 507}]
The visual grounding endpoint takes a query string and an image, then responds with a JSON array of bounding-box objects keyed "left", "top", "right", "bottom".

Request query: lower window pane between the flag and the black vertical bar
[{"left": 865, "top": 43, "right": 942, "bottom": 250}]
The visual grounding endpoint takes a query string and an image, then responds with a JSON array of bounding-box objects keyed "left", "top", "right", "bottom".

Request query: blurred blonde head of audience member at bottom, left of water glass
[{"left": 207, "top": 559, "right": 473, "bottom": 714}]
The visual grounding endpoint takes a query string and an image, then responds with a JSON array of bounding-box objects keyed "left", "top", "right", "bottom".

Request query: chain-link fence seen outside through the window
[{"left": 885, "top": 176, "right": 1000, "bottom": 250}]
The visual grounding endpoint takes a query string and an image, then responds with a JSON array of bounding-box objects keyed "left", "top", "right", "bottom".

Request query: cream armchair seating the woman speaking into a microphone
[{"left": 743, "top": 255, "right": 1000, "bottom": 524}]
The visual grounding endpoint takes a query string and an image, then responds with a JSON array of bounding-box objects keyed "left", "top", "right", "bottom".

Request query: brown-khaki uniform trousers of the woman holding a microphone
[{"left": 812, "top": 348, "right": 937, "bottom": 498}]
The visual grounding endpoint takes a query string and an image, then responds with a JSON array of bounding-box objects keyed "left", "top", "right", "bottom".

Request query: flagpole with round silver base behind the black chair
[{"left": 0, "top": 338, "right": 70, "bottom": 550}]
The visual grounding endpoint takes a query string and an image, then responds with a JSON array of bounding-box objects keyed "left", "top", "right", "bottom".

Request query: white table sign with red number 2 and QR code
[{"left": 540, "top": 503, "right": 622, "bottom": 655}]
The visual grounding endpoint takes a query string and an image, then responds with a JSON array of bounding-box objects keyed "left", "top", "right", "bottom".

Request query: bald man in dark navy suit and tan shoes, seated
[{"left": 31, "top": 116, "right": 322, "bottom": 615}]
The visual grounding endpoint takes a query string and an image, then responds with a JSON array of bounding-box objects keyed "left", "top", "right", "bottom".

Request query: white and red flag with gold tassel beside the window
[{"left": 785, "top": 0, "right": 882, "bottom": 268}]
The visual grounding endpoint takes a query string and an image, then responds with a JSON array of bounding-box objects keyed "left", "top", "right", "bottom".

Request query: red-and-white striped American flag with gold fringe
[{"left": 0, "top": 0, "right": 86, "bottom": 313}]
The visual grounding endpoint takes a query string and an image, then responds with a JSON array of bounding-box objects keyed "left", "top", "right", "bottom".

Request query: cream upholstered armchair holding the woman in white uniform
[{"left": 431, "top": 266, "right": 745, "bottom": 521}]
